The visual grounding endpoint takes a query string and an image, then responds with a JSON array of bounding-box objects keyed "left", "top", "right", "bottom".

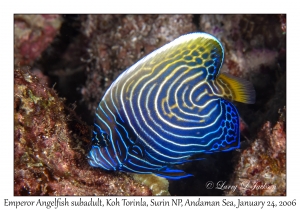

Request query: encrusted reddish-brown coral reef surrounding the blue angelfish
[{"left": 14, "top": 14, "right": 286, "bottom": 195}]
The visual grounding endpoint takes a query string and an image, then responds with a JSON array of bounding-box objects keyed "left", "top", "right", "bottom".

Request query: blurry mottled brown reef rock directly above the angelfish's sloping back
[{"left": 81, "top": 15, "right": 196, "bottom": 121}]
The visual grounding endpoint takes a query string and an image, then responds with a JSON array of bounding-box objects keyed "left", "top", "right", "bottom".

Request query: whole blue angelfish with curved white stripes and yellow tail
[{"left": 88, "top": 32, "right": 255, "bottom": 179}]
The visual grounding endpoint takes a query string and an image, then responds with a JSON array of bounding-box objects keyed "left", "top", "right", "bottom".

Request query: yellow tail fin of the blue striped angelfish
[{"left": 216, "top": 73, "right": 256, "bottom": 104}]
